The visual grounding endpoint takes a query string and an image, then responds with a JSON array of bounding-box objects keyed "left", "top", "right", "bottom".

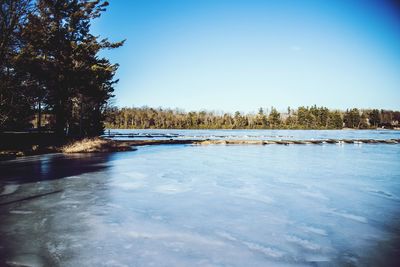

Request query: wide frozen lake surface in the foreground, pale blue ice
[{"left": 0, "top": 131, "right": 400, "bottom": 266}]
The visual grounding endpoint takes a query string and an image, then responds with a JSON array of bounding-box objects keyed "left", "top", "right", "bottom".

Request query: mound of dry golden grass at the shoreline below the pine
[{"left": 61, "top": 137, "right": 135, "bottom": 153}]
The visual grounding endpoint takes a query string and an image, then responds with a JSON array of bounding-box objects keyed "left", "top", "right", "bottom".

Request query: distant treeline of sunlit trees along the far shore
[{"left": 105, "top": 105, "right": 400, "bottom": 129}]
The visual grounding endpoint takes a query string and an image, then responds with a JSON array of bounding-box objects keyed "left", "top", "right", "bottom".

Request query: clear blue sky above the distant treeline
[{"left": 92, "top": 0, "right": 400, "bottom": 112}]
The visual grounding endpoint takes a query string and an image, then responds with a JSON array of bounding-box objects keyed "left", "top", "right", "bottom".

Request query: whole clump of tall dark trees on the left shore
[{"left": 0, "top": 0, "right": 123, "bottom": 136}]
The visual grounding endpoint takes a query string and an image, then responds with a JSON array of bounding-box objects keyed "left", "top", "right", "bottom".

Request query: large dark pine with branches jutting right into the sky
[{"left": 22, "top": 0, "right": 123, "bottom": 136}]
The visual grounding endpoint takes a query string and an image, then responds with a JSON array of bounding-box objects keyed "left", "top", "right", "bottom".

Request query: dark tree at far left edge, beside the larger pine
[{"left": 0, "top": 0, "right": 34, "bottom": 130}]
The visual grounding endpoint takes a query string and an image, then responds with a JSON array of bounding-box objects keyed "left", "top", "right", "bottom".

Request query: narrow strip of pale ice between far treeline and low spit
[{"left": 106, "top": 129, "right": 400, "bottom": 140}]
